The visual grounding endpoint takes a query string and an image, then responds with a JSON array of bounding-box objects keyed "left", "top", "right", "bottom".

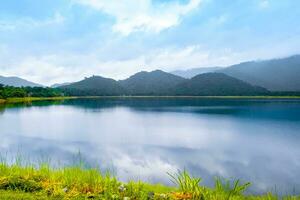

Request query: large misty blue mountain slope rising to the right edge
[{"left": 217, "top": 55, "right": 300, "bottom": 91}]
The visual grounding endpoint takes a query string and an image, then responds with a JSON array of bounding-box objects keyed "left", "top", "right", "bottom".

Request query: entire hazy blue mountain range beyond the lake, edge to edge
[{"left": 0, "top": 55, "right": 300, "bottom": 96}]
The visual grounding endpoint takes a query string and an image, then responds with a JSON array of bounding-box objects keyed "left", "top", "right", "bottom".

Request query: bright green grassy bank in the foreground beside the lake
[{"left": 0, "top": 163, "right": 299, "bottom": 200}]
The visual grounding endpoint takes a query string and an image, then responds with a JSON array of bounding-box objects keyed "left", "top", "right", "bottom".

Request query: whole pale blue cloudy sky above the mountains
[{"left": 0, "top": 0, "right": 300, "bottom": 85}]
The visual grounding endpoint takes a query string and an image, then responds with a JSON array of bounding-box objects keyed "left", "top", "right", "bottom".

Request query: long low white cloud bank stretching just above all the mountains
[{"left": 0, "top": 35, "right": 300, "bottom": 85}]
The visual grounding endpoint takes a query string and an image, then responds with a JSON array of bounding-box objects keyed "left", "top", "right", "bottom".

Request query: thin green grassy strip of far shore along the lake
[{"left": 0, "top": 96, "right": 300, "bottom": 104}]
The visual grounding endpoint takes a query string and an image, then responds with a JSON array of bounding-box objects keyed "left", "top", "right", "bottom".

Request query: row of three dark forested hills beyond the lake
[{"left": 59, "top": 70, "right": 268, "bottom": 96}]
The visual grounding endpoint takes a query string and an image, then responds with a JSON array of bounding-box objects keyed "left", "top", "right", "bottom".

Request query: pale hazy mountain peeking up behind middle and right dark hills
[{"left": 170, "top": 67, "right": 222, "bottom": 78}]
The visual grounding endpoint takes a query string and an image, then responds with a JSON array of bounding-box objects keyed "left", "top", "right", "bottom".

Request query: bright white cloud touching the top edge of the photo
[{"left": 74, "top": 0, "right": 201, "bottom": 35}]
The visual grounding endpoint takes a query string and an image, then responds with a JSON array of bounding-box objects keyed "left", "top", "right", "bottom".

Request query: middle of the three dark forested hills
[{"left": 119, "top": 70, "right": 185, "bottom": 95}]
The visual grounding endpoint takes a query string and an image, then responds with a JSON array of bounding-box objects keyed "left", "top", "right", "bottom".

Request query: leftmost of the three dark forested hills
[{"left": 59, "top": 76, "right": 126, "bottom": 96}]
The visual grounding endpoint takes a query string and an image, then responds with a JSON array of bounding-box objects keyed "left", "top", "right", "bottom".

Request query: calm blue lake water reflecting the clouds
[{"left": 0, "top": 98, "right": 300, "bottom": 194}]
